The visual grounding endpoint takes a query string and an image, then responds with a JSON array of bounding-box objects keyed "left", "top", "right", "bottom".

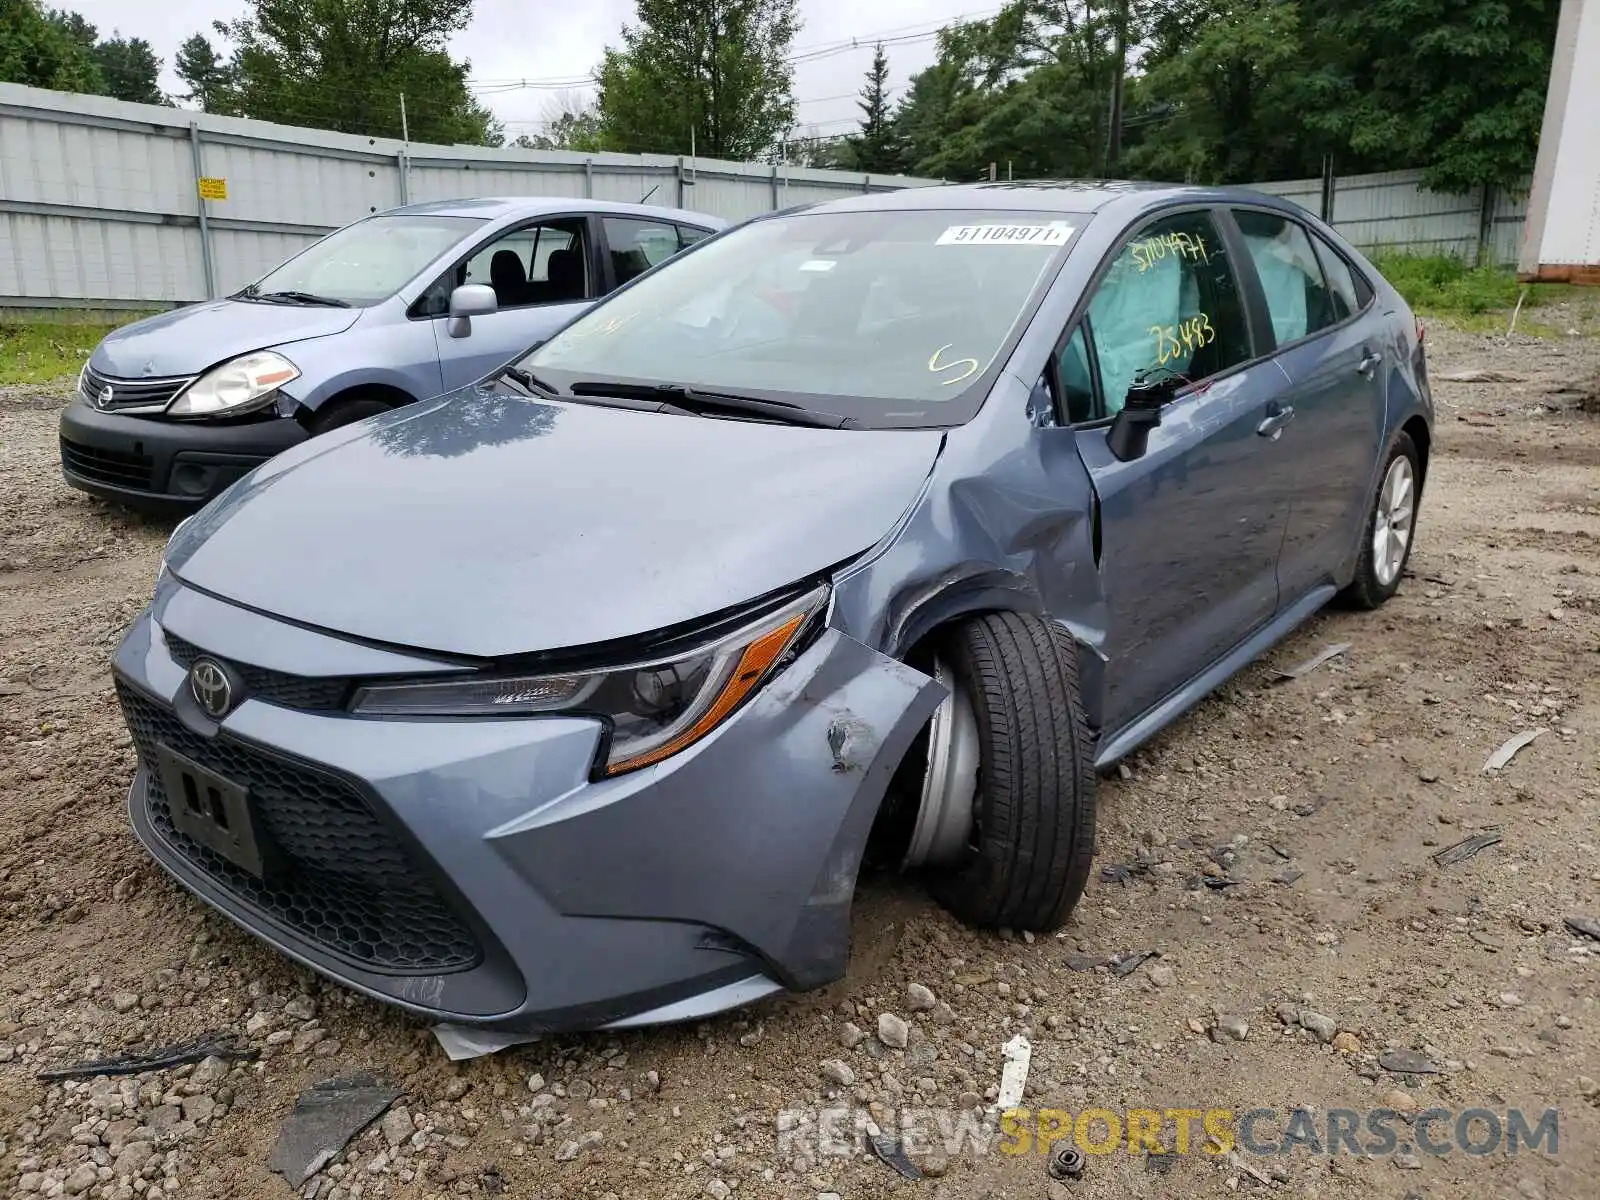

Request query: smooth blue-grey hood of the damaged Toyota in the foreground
[{"left": 168, "top": 386, "right": 942, "bottom": 658}]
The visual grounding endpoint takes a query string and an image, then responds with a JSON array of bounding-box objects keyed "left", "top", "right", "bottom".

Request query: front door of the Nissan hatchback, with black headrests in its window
[{"left": 418, "top": 216, "right": 603, "bottom": 392}]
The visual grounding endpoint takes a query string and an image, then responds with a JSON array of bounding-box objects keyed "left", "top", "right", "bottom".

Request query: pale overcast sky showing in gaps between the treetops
[{"left": 62, "top": 0, "right": 1000, "bottom": 138}]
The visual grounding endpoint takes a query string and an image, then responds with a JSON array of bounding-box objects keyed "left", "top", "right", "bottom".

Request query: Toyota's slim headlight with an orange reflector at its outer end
[{"left": 350, "top": 587, "right": 827, "bottom": 774}]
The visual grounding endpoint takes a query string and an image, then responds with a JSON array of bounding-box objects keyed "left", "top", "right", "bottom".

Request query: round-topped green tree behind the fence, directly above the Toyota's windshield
[{"left": 598, "top": 0, "right": 800, "bottom": 158}]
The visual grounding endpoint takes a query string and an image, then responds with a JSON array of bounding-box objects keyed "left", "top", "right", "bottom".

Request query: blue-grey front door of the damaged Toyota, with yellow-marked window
[{"left": 1058, "top": 210, "right": 1291, "bottom": 733}]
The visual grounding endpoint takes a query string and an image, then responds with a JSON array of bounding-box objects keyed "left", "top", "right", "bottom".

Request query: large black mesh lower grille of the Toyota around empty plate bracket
[{"left": 117, "top": 680, "right": 483, "bottom": 974}]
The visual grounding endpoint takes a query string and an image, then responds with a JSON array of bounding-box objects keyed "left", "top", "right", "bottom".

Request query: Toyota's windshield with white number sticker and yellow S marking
[{"left": 518, "top": 210, "right": 1085, "bottom": 424}]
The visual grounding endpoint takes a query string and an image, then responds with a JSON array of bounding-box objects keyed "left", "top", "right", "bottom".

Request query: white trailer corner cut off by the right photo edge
[{"left": 1517, "top": 0, "right": 1600, "bottom": 285}]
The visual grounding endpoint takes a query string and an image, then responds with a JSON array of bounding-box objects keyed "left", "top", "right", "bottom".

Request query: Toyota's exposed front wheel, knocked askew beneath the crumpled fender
[{"left": 906, "top": 613, "right": 1094, "bottom": 931}]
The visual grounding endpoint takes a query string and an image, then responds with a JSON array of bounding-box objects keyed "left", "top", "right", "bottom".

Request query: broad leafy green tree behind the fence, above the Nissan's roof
[{"left": 201, "top": 0, "right": 504, "bottom": 146}]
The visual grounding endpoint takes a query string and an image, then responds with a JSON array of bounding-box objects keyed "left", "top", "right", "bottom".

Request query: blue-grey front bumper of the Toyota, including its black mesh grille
[{"left": 115, "top": 578, "right": 942, "bottom": 1032}]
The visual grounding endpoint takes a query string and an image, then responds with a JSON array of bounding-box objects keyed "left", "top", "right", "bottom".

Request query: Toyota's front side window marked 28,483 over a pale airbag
[{"left": 1088, "top": 213, "right": 1251, "bottom": 416}]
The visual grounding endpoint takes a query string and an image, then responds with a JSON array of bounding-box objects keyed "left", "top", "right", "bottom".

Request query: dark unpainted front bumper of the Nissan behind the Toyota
[{"left": 61, "top": 400, "right": 307, "bottom": 510}]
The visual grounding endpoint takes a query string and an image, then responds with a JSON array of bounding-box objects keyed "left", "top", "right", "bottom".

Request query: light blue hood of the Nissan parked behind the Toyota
[{"left": 90, "top": 299, "right": 362, "bottom": 379}]
